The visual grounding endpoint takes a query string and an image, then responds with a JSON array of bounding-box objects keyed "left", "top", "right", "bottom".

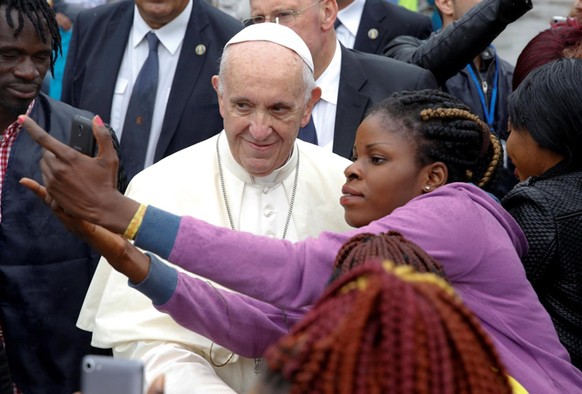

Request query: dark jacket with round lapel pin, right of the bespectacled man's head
[{"left": 354, "top": 0, "right": 432, "bottom": 54}]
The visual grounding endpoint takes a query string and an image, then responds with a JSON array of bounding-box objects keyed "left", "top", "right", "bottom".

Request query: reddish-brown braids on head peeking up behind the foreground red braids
[{"left": 330, "top": 231, "right": 446, "bottom": 282}]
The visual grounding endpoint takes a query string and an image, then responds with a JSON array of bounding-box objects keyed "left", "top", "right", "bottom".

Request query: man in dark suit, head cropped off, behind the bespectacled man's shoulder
[{"left": 336, "top": 0, "right": 432, "bottom": 55}]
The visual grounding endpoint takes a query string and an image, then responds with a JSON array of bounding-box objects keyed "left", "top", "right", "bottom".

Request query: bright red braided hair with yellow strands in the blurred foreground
[{"left": 259, "top": 261, "right": 512, "bottom": 394}]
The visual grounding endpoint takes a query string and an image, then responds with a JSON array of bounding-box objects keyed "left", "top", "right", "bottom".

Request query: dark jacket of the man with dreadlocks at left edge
[{"left": 0, "top": 94, "right": 112, "bottom": 394}]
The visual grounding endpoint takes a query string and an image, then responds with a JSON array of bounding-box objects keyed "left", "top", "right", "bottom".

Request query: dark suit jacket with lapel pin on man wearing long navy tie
[{"left": 62, "top": 0, "right": 242, "bottom": 161}]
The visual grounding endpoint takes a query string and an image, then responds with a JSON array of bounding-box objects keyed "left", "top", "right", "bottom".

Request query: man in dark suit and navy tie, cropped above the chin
[{"left": 62, "top": 0, "right": 242, "bottom": 179}]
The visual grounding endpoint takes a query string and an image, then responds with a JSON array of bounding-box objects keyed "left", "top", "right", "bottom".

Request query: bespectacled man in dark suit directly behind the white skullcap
[{"left": 245, "top": 0, "right": 437, "bottom": 158}]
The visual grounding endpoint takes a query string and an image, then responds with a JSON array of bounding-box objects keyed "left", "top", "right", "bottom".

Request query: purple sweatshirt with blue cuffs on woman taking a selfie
[{"left": 135, "top": 183, "right": 582, "bottom": 394}]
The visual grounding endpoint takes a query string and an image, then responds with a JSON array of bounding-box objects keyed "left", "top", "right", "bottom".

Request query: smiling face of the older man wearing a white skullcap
[{"left": 212, "top": 42, "right": 310, "bottom": 176}]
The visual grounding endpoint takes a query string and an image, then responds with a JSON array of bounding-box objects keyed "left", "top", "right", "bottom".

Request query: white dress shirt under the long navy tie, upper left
[{"left": 109, "top": 0, "right": 192, "bottom": 167}]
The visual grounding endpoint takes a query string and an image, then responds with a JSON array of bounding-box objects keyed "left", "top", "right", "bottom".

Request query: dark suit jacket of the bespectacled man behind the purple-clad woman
[{"left": 333, "top": 46, "right": 438, "bottom": 158}]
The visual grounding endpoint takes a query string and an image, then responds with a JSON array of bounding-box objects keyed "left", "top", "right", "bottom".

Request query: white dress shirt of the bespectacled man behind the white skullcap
[{"left": 311, "top": 42, "right": 342, "bottom": 152}]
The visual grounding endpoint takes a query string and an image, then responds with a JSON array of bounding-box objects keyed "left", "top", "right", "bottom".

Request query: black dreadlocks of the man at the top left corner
[{"left": 0, "top": 0, "right": 62, "bottom": 73}]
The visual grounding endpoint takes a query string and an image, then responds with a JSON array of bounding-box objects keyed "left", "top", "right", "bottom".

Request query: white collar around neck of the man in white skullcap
[{"left": 218, "top": 130, "right": 299, "bottom": 186}]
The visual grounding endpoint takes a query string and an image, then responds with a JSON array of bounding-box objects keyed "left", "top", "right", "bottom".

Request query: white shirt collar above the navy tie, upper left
[{"left": 132, "top": 0, "right": 192, "bottom": 55}]
